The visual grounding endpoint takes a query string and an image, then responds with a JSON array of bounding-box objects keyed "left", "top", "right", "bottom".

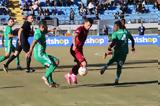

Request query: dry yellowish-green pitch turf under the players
[{"left": 0, "top": 46, "right": 160, "bottom": 106}]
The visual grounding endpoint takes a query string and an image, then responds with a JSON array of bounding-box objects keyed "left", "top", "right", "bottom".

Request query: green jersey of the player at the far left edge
[{"left": 4, "top": 25, "right": 12, "bottom": 47}]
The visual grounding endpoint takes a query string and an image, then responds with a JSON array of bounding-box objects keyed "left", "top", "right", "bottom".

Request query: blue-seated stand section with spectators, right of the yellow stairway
[{"left": 19, "top": 0, "right": 159, "bottom": 24}]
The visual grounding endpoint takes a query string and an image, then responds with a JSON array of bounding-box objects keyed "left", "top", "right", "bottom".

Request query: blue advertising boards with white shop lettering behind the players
[{"left": 0, "top": 35, "right": 160, "bottom": 47}]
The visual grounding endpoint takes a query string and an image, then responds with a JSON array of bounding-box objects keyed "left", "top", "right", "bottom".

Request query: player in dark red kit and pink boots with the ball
[{"left": 65, "top": 18, "right": 93, "bottom": 85}]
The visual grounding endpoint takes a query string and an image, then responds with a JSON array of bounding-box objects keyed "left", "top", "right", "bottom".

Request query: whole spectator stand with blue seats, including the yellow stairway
[{"left": 0, "top": 0, "right": 159, "bottom": 24}]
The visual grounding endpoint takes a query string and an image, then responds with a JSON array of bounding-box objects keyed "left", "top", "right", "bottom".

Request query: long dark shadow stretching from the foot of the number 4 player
[{"left": 61, "top": 80, "right": 158, "bottom": 89}]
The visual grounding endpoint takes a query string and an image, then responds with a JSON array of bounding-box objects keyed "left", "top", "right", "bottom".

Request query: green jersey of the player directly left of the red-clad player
[{"left": 34, "top": 29, "right": 46, "bottom": 54}]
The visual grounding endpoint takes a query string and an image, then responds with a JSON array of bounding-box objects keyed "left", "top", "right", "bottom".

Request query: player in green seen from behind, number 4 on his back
[{"left": 100, "top": 21, "right": 135, "bottom": 84}]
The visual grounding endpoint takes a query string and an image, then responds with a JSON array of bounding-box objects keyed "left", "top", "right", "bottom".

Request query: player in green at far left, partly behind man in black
[{"left": 0, "top": 18, "right": 21, "bottom": 72}]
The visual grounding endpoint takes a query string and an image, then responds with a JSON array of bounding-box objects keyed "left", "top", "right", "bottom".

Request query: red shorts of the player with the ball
[{"left": 70, "top": 46, "right": 86, "bottom": 64}]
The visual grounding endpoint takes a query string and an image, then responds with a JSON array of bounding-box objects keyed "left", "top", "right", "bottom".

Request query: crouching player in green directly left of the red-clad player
[{"left": 27, "top": 21, "right": 59, "bottom": 87}]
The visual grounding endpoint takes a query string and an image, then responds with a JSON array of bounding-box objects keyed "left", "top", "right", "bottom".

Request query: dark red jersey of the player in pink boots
[{"left": 75, "top": 26, "right": 88, "bottom": 49}]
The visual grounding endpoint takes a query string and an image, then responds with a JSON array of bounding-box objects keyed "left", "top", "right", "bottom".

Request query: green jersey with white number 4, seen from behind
[{"left": 112, "top": 29, "right": 132, "bottom": 54}]
